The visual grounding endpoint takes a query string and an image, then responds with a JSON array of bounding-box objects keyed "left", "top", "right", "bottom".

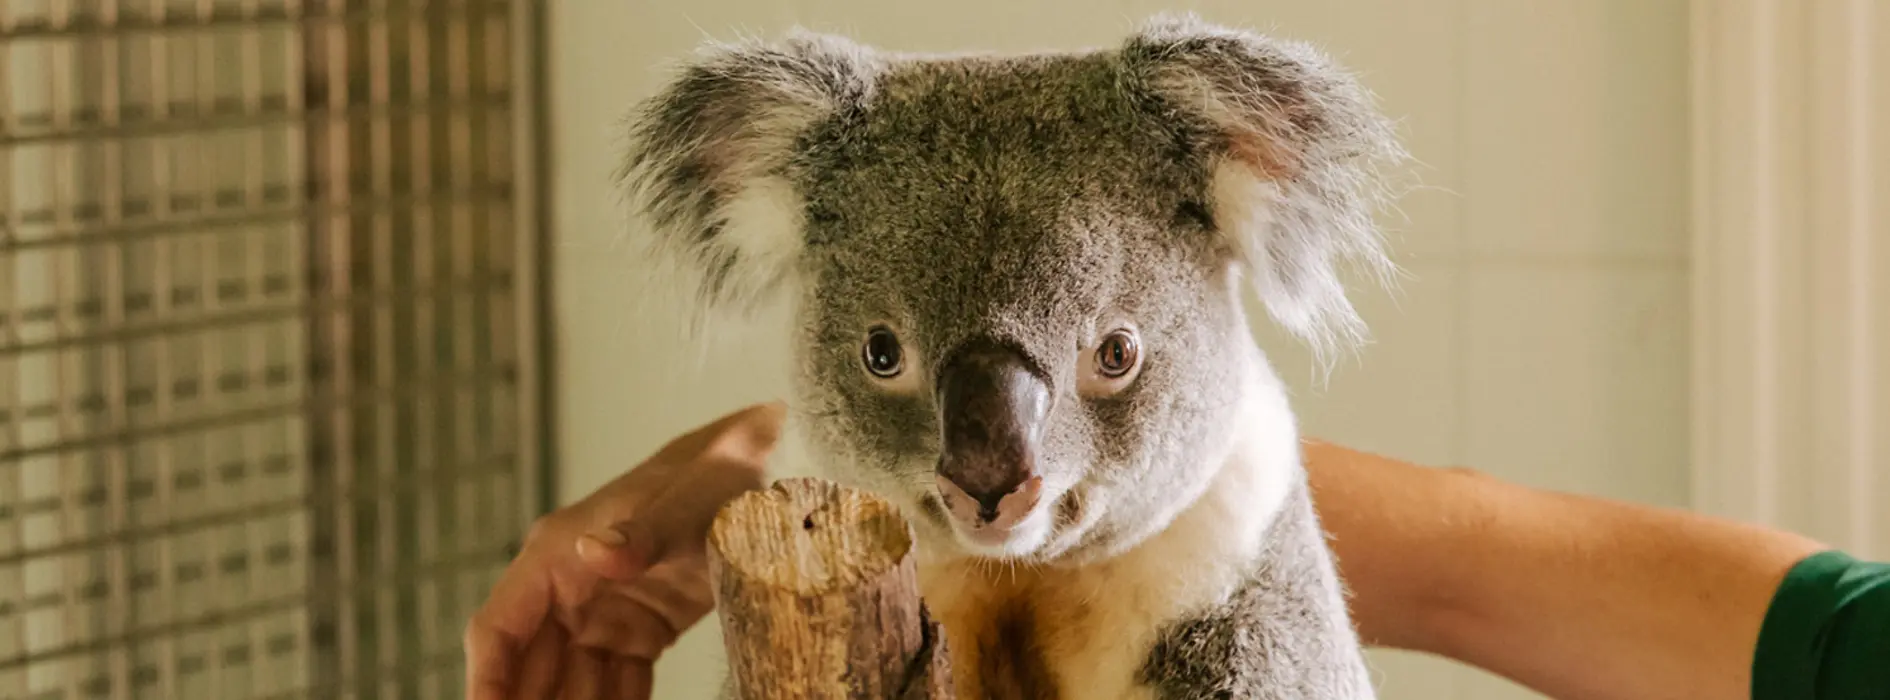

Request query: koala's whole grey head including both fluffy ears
[{"left": 622, "top": 17, "right": 1402, "bottom": 564}]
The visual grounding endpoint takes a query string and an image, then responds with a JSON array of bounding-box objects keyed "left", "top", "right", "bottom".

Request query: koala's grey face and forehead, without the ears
[{"left": 796, "top": 55, "right": 1251, "bottom": 556}]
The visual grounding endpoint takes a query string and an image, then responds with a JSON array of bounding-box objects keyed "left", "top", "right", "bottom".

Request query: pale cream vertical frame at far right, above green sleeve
[{"left": 1692, "top": 0, "right": 1890, "bottom": 558}]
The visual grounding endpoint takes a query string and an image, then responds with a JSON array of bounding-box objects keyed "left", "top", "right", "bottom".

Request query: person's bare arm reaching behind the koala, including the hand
[{"left": 467, "top": 407, "right": 1824, "bottom": 700}]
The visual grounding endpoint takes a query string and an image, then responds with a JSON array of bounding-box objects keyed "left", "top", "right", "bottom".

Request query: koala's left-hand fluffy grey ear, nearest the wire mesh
[{"left": 618, "top": 30, "right": 879, "bottom": 325}]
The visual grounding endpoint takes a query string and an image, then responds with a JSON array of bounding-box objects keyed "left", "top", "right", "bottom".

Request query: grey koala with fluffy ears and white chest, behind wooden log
[{"left": 618, "top": 15, "right": 1404, "bottom": 700}]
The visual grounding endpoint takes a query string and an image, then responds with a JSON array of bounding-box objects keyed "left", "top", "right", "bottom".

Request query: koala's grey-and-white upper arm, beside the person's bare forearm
[{"left": 1140, "top": 474, "right": 1376, "bottom": 700}]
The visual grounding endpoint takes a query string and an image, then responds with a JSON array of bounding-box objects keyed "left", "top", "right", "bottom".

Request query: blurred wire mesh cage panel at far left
[{"left": 0, "top": 0, "right": 544, "bottom": 698}]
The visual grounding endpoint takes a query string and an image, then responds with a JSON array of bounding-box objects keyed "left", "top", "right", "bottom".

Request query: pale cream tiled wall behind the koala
[{"left": 550, "top": 0, "right": 1688, "bottom": 700}]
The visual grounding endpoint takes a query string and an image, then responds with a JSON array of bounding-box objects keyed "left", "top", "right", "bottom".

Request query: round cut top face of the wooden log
[{"left": 709, "top": 479, "right": 913, "bottom": 594}]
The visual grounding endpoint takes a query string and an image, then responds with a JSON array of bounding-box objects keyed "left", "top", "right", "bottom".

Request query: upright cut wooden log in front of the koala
[{"left": 709, "top": 479, "right": 951, "bottom": 700}]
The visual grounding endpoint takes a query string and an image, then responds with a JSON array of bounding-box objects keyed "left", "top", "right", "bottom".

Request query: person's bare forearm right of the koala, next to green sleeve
[{"left": 1306, "top": 443, "right": 1824, "bottom": 700}]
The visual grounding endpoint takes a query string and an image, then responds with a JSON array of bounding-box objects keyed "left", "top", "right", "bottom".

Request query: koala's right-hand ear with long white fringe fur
[{"left": 1123, "top": 15, "right": 1404, "bottom": 358}]
